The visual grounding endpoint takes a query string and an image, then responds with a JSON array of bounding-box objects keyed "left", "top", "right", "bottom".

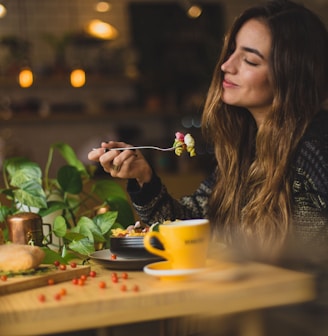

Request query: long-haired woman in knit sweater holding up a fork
[{"left": 88, "top": 0, "right": 328, "bottom": 258}]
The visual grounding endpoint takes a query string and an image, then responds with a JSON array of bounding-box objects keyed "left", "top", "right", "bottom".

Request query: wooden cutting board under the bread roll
[{"left": 0, "top": 265, "right": 91, "bottom": 295}]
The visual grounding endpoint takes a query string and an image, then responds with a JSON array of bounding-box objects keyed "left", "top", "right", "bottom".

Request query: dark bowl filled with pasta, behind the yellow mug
[{"left": 110, "top": 222, "right": 163, "bottom": 259}]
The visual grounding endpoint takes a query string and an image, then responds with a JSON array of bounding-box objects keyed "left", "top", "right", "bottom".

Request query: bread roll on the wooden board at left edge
[{"left": 0, "top": 243, "right": 45, "bottom": 272}]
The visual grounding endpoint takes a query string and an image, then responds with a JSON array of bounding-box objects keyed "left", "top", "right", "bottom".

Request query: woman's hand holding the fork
[{"left": 88, "top": 141, "right": 152, "bottom": 187}]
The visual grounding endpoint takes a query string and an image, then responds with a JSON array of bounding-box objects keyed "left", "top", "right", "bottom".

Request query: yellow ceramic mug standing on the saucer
[{"left": 144, "top": 219, "right": 210, "bottom": 269}]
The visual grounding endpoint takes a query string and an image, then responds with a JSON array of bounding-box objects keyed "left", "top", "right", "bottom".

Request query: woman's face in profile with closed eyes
[{"left": 221, "top": 19, "right": 273, "bottom": 126}]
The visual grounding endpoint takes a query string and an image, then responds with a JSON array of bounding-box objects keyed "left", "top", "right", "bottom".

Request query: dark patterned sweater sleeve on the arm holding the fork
[{"left": 127, "top": 172, "right": 215, "bottom": 224}]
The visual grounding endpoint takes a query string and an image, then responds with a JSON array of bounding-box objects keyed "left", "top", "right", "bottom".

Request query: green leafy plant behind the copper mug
[{"left": 0, "top": 143, "right": 134, "bottom": 263}]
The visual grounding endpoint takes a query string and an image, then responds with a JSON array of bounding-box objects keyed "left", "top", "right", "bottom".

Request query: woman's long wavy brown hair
[{"left": 203, "top": 0, "right": 328, "bottom": 254}]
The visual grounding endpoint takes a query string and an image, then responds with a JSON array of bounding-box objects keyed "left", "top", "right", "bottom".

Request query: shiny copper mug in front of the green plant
[{"left": 7, "top": 212, "right": 52, "bottom": 246}]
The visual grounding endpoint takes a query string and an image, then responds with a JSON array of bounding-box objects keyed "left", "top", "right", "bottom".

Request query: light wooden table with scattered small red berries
[{"left": 0, "top": 263, "right": 315, "bottom": 336}]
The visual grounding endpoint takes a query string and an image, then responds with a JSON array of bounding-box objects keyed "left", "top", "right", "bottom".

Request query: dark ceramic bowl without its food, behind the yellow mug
[{"left": 110, "top": 236, "right": 163, "bottom": 259}]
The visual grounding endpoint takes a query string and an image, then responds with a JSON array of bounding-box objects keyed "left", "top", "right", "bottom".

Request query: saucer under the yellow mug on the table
[{"left": 143, "top": 260, "right": 215, "bottom": 280}]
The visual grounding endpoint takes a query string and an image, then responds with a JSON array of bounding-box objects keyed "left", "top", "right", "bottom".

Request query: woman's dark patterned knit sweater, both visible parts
[{"left": 127, "top": 111, "right": 328, "bottom": 262}]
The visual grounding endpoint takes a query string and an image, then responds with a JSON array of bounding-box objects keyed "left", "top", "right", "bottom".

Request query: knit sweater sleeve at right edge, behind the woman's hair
[{"left": 293, "top": 113, "right": 328, "bottom": 258}]
